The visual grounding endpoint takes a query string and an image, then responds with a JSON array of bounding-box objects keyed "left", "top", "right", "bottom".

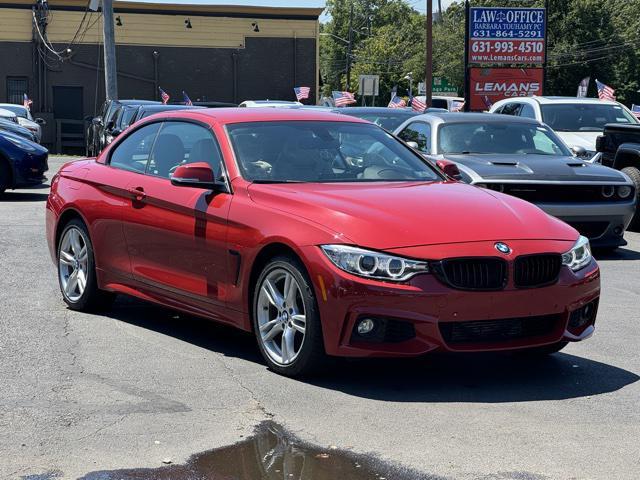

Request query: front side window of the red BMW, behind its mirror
[{"left": 147, "top": 122, "right": 222, "bottom": 178}]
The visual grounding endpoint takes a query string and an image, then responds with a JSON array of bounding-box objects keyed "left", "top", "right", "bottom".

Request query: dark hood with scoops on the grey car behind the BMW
[{"left": 445, "top": 154, "right": 626, "bottom": 183}]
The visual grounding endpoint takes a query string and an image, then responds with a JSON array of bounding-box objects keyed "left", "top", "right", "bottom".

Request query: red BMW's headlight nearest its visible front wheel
[{"left": 321, "top": 245, "right": 429, "bottom": 282}]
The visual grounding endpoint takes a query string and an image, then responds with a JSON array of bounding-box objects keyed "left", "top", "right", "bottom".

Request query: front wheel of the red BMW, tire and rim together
[{"left": 252, "top": 255, "right": 326, "bottom": 377}]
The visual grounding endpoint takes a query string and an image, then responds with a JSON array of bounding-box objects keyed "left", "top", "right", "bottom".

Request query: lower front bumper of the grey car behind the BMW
[{"left": 536, "top": 200, "right": 636, "bottom": 248}]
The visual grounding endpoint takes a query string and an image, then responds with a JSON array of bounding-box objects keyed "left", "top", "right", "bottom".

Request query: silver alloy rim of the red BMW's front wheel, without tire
[{"left": 256, "top": 268, "right": 306, "bottom": 365}]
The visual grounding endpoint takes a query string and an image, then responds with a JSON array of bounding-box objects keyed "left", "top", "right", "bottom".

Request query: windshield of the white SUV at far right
[{"left": 540, "top": 103, "right": 638, "bottom": 132}]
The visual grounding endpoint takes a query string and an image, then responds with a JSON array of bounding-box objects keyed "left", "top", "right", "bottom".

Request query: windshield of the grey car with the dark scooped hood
[{"left": 438, "top": 122, "right": 571, "bottom": 156}]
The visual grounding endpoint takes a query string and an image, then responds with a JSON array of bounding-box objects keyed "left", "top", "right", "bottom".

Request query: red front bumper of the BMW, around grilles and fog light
[{"left": 304, "top": 241, "right": 600, "bottom": 357}]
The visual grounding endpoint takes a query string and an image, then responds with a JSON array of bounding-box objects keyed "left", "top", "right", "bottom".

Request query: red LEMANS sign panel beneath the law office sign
[{"left": 469, "top": 68, "right": 544, "bottom": 110}]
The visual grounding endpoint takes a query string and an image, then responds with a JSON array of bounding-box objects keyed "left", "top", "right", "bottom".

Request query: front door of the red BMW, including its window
[{"left": 123, "top": 120, "right": 232, "bottom": 308}]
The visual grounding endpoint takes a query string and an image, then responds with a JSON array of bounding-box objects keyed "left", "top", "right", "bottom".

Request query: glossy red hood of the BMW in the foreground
[{"left": 249, "top": 182, "right": 578, "bottom": 250}]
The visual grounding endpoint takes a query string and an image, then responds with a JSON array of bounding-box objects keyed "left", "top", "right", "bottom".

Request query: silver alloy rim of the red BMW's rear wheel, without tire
[{"left": 58, "top": 227, "right": 89, "bottom": 302}]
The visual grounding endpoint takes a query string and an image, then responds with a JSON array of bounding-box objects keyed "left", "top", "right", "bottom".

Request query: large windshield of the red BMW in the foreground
[{"left": 227, "top": 121, "right": 442, "bottom": 183}]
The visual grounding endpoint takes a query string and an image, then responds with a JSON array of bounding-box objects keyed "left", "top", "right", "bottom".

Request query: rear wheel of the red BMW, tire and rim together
[{"left": 57, "top": 219, "right": 115, "bottom": 312}]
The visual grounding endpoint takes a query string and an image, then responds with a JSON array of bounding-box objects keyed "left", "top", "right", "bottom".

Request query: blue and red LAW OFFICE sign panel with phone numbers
[{"left": 468, "top": 7, "right": 546, "bottom": 65}]
